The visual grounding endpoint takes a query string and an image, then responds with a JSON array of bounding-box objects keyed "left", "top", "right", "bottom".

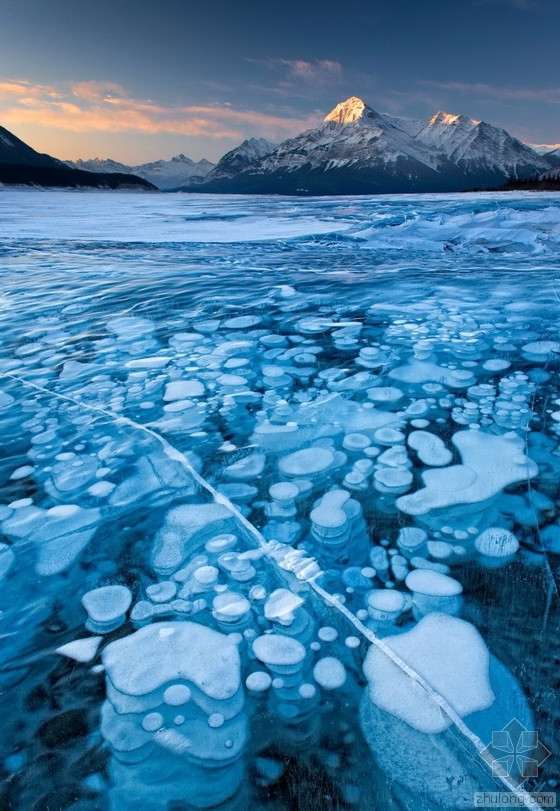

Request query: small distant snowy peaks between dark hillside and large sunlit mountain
[{"left": 66, "top": 154, "right": 214, "bottom": 191}]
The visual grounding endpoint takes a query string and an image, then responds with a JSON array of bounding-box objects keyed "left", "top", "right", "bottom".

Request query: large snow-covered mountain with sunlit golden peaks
[{"left": 192, "top": 96, "right": 552, "bottom": 194}]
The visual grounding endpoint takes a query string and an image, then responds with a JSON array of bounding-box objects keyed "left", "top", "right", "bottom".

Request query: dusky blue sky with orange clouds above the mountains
[{"left": 0, "top": 0, "right": 560, "bottom": 165}]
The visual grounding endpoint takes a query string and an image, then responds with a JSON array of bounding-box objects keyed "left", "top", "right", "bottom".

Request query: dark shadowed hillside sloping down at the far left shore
[{"left": 0, "top": 127, "right": 155, "bottom": 190}]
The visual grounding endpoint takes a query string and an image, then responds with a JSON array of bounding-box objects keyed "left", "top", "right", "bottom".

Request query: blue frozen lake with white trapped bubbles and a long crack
[{"left": 0, "top": 189, "right": 560, "bottom": 811}]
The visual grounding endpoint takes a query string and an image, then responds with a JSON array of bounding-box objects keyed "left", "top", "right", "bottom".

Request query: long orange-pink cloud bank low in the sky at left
[{"left": 0, "top": 77, "right": 314, "bottom": 140}]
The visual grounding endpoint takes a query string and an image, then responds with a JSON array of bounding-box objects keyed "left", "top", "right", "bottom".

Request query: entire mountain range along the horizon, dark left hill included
[{"left": 0, "top": 96, "right": 560, "bottom": 195}]
